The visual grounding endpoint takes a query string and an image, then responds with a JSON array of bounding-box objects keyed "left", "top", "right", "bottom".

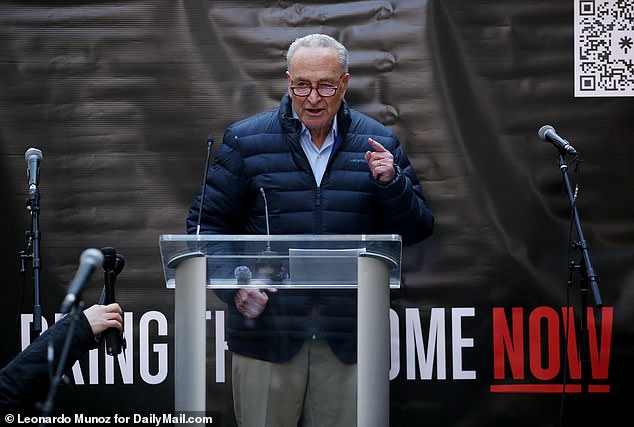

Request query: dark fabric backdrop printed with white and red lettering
[{"left": 0, "top": 0, "right": 634, "bottom": 426}]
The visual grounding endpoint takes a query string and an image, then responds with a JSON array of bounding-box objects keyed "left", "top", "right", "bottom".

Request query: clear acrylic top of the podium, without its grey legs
[{"left": 160, "top": 234, "right": 402, "bottom": 289}]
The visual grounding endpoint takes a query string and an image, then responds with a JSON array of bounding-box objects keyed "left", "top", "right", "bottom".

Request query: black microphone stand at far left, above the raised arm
[{"left": 20, "top": 184, "right": 42, "bottom": 339}]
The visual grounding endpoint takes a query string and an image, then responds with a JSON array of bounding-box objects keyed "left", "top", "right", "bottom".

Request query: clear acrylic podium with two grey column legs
[{"left": 160, "top": 234, "right": 402, "bottom": 427}]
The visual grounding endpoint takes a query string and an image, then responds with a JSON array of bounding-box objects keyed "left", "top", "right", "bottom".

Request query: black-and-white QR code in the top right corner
[{"left": 574, "top": 0, "right": 634, "bottom": 97}]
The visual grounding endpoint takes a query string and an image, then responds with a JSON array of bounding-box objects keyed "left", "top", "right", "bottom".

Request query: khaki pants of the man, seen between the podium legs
[{"left": 232, "top": 340, "right": 357, "bottom": 427}]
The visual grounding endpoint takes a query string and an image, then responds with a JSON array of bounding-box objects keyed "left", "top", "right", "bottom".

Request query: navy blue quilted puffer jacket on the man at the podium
[{"left": 187, "top": 94, "right": 434, "bottom": 363}]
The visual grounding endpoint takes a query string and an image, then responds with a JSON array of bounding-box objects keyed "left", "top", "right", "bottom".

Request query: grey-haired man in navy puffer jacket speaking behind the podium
[{"left": 187, "top": 34, "right": 434, "bottom": 427}]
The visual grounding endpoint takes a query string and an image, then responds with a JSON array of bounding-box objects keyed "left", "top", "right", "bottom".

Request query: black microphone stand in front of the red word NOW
[{"left": 559, "top": 151, "right": 603, "bottom": 400}]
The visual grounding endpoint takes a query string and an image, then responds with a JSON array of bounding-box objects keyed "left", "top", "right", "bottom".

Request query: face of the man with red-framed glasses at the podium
[{"left": 286, "top": 47, "right": 350, "bottom": 139}]
